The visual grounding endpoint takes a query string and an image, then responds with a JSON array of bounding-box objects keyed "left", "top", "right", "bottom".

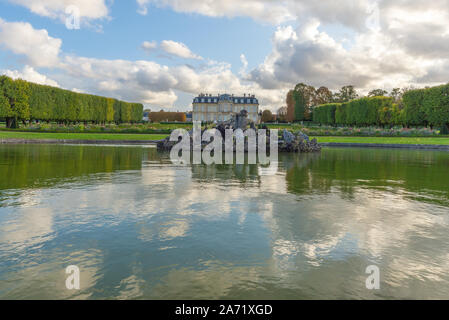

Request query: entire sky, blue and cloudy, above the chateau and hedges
[{"left": 0, "top": 0, "right": 449, "bottom": 111}]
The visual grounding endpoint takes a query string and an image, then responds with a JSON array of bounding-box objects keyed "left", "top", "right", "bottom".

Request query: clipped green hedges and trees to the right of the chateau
[{"left": 287, "top": 83, "right": 449, "bottom": 131}]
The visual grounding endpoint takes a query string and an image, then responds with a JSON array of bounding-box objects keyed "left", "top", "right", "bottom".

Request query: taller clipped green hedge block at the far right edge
[{"left": 403, "top": 84, "right": 449, "bottom": 127}]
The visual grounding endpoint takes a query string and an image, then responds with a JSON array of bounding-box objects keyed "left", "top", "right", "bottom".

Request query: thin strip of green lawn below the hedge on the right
[{"left": 315, "top": 136, "right": 449, "bottom": 145}]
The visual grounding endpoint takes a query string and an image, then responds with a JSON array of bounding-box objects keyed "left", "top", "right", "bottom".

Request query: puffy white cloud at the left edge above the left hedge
[{"left": 0, "top": 19, "right": 62, "bottom": 67}]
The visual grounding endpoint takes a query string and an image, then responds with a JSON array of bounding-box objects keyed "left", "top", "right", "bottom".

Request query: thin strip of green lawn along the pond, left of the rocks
[{"left": 0, "top": 131, "right": 167, "bottom": 140}]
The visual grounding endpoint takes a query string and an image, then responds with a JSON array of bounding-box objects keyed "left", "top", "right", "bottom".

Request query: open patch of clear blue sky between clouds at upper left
[{"left": 0, "top": 0, "right": 275, "bottom": 72}]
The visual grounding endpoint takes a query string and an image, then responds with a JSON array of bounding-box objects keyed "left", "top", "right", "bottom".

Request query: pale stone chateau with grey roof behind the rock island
[{"left": 193, "top": 94, "right": 260, "bottom": 123}]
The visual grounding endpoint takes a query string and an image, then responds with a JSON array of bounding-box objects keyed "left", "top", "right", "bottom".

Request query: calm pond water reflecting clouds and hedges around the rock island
[{"left": 0, "top": 145, "right": 449, "bottom": 299}]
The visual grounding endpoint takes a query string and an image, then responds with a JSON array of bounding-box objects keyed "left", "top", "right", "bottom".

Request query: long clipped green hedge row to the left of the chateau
[{"left": 0, "top": 76, "right": 143, "bottom": 128}]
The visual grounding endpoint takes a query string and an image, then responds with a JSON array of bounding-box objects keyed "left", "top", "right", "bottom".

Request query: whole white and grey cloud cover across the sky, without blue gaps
[{"left": 0, "top": 0, "right": 449, "bottom": 111}]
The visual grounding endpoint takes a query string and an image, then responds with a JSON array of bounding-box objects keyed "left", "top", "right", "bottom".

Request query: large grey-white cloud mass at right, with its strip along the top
[{"left": 139, "top": 0, "right": 449, "bottom": 90}]
